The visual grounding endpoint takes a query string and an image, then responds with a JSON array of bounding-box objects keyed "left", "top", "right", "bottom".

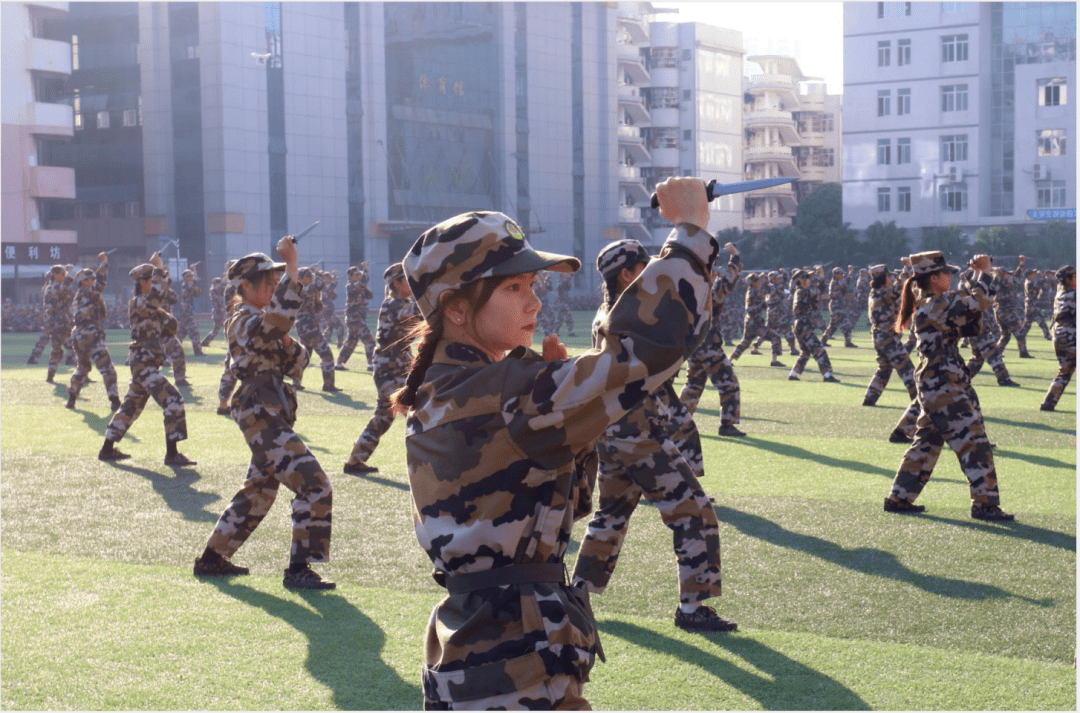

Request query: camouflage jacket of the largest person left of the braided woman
[{"left": 225, "top": 274, "right": 308, "bottom": 423}]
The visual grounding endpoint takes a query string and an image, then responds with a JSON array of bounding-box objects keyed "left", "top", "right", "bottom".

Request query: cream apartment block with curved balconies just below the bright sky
[{"left": 742, "top": 55, "right": 842, "bottom": 232}]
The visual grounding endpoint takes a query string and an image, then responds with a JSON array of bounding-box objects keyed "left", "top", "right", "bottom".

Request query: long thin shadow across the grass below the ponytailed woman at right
[{"left": 715, "top": 506, "right": 1054, "bottom": 607}]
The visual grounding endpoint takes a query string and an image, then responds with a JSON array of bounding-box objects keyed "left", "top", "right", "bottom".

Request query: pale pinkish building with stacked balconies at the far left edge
[{"left": 0, "top": 2, "right": 78, "bottom": 301}]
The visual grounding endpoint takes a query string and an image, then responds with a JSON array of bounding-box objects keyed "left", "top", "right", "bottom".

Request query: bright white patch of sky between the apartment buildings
[{"left": 652, "top": 1, "right": 843, "bottom": 94}]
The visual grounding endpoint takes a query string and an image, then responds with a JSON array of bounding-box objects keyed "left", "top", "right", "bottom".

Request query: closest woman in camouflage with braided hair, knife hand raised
[{"left": 395, "top": 177, "right": 718, "bottom": 710}]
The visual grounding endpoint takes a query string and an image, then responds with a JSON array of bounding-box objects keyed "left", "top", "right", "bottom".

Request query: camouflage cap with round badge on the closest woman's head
[{"left": 402, "top": 211, "right": 581, "bottom": 319}]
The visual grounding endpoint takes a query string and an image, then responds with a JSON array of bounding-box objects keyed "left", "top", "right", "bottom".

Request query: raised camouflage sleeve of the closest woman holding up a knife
[{"left": 502, "top": 225, "right": 717, "bottom": 467}]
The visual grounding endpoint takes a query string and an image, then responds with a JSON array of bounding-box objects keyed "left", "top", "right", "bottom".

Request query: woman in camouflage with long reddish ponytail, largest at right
[{"left": 885, "top": 251, "right": 1013, "bottom": 521}]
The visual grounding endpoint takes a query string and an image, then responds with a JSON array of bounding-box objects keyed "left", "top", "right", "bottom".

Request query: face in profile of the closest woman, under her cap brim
[{"left": 472, "top": 272, "right": 540, "bottom": 361}]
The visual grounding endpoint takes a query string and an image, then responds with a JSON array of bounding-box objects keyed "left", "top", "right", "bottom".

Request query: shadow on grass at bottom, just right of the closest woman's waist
[{"left": 598, "top": 620, "right": 870, "bottom": 711}]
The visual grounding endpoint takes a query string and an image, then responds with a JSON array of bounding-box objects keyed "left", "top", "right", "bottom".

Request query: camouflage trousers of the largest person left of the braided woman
[{"left": 206, "top": 401, "right": 334, "bottom": 563}]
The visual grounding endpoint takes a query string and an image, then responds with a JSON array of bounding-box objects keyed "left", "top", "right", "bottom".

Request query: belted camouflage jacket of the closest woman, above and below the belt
[{"left": 406, "top": 221, "right": 718, "bottom": 701}]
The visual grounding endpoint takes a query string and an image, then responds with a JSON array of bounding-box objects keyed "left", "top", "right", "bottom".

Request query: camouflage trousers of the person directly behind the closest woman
[{"left": 570, "top": 434, "right": 720, "bottom": 604}]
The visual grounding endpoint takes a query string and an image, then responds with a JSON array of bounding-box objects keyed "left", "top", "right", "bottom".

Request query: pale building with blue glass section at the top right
[{"left": 843, "top": 2, "right": 1077, "bottom": 243}]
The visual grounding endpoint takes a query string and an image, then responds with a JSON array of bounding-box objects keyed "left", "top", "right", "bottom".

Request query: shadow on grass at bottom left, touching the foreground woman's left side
[{"left": 203, "top": 577, "right": 423, "bottom": 711}]
